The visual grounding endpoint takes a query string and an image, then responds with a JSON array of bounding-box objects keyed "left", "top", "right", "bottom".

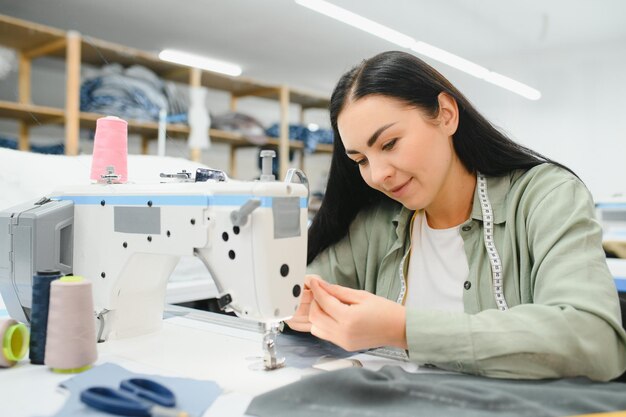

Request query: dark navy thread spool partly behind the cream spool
[{"left": 28, "top": 270, "right": 62, "bottom": 365}]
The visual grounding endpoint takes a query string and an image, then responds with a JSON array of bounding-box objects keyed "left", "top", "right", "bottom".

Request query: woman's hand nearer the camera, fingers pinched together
[{"left": 309, "top": 279, "right": 407, "bottom": 351}]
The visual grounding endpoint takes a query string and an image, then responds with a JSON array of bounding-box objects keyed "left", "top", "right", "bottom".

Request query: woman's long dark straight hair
[{"left": 307, "top": 51, "right": 567, "bottom": 263}]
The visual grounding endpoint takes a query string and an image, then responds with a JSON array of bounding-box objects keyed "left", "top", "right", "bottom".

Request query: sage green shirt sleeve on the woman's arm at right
[{"left": 407, "top": 178, "right": 626, "bottom": 381}]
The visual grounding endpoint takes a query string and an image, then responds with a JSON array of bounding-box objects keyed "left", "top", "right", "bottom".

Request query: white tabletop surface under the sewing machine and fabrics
[{"left": 0, "top": 306, "right": 417, "bottom": 417}]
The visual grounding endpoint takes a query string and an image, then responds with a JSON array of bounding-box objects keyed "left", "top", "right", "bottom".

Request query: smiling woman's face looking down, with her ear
[{"left": 337, "top": 94, "right": 458, "bottom": 210}]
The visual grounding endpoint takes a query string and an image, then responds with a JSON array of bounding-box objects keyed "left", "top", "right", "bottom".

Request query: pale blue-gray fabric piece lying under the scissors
[{"left": 54, "top": 363, "right": 222, "bottom": 417}]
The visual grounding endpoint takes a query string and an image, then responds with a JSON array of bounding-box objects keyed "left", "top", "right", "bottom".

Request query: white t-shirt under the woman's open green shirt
[{"left": 404, "top": 210, "right": 469, "bottom": 312}]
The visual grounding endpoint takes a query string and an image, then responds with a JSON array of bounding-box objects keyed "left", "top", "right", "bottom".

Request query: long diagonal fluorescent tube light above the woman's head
[{"left": 295, "top": 0, "right": 541, "bottom": 100}]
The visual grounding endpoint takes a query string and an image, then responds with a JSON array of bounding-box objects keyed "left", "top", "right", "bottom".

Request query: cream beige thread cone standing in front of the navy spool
[{"left": 45, "top": 276, "right": 98, "bottom": 373}]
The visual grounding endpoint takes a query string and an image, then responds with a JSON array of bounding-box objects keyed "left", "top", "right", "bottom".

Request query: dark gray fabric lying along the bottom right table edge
[{"left": 246, "top": 366, "right": 626, "bottom": 417}]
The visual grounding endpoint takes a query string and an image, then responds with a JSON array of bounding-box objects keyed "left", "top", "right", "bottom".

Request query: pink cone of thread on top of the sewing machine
[{"left": 90, "top": 116, "right": 128, "bottom": 183}]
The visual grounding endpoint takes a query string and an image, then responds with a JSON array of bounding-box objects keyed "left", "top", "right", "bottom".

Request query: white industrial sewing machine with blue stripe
[{"left": 0, "top": 155, "right": 308, "bottom": 369}]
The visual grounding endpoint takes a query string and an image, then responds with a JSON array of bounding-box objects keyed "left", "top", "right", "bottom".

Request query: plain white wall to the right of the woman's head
[{"left": 446, "top": 39, "right": 626, "bottom": 201}]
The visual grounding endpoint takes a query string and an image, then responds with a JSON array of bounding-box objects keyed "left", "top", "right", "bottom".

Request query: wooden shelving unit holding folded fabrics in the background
[{"left": 0, "top": 15, "right": 332, "bottom": 178}]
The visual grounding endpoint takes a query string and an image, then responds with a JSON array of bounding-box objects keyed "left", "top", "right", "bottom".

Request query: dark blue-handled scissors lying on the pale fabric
[{"left": 80, "top": 378, "right": 189, "bottom": 417}]
